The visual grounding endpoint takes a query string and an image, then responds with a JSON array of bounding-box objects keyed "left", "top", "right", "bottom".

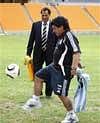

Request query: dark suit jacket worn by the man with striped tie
[{"left": 27, "top": 21, "right": 57, "bottom": 62}]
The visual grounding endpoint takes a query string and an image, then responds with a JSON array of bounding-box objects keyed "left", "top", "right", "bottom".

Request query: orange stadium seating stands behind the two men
[{"left": 0, "top": 0, "right": 100, "bottom": 33}]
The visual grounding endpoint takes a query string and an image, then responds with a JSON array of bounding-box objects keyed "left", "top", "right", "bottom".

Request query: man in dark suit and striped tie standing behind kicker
[{"left": 24, "top": 7, "right": 56, "bottom": 96}]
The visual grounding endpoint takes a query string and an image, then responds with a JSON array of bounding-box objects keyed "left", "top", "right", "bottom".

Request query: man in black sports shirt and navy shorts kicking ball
[{"left": 23, "top": 16, "right": 81, "bottom": 123}]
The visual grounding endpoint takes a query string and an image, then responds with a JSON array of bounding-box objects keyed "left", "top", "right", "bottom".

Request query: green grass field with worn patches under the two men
[{"left": 0, "top": 35, "right": 100, "bottom": 123}]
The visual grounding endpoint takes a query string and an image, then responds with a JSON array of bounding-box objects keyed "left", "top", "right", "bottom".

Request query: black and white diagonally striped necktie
[{"left": 42, "top": 24, "right": 47, "bottom": 51}]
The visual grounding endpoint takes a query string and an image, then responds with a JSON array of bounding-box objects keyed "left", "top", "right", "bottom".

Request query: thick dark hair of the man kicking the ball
[{"left": 51, "top": 16, "right": 70, "bottom": 31}]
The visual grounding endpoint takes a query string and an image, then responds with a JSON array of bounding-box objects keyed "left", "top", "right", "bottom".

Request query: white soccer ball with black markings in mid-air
[{"left": 5, "top": 64, "right": 20, "bottom": 79}]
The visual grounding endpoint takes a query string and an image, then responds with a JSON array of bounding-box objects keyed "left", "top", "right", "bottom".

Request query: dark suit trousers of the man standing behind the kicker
[{"left": 33, "top": 52, "right": 52, "bottom": 96}]
